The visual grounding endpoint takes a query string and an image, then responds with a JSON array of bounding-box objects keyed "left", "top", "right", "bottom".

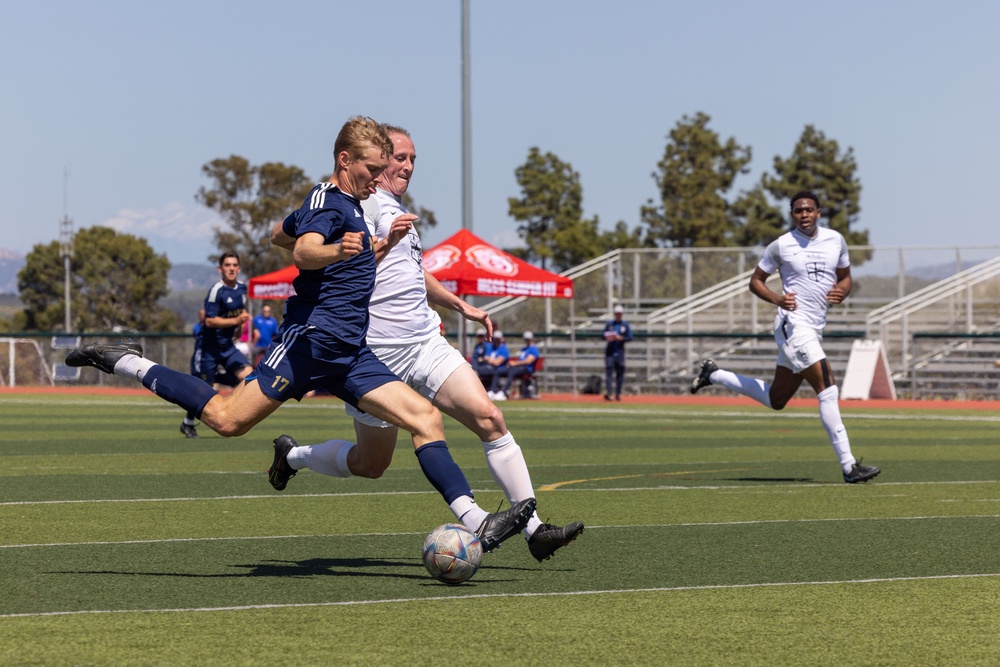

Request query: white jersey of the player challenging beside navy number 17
[{"left": 361, "top": 188, "right": 441, "bottom": 345}]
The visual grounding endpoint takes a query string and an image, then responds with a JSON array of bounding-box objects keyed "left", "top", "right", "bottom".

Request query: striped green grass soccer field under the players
[{"left": 0, "top": 394, "right": 1000, "bottom": 666}]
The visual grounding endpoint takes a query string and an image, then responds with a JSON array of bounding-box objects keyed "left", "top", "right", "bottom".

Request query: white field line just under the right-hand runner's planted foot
[{"left": 0, "top": 479, "right": 1000, "bottom": 507}]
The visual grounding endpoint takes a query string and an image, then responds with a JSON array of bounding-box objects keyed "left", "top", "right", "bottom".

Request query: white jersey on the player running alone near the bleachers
[{"left": 757, "top": 227, "right": 851, "bottom": 330}]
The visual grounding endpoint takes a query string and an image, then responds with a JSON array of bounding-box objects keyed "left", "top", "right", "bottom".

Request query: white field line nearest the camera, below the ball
[{"left": 0, "top": 572, "right": 1000, "bottom": 619}]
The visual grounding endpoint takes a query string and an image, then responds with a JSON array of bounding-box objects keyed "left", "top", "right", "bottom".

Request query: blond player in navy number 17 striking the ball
[{"left": 66, "top": 116, "right": 535, "bottom": 551}]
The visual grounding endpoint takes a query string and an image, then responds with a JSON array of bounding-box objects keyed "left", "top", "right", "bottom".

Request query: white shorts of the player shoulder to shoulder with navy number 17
[{"left": 345, "top": 335, "right": 469, "bottom": 428}]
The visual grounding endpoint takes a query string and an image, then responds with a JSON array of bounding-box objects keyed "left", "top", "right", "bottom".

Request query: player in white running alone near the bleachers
[{"left": 691, "top": 192, "right": 881, "bottom": 484}]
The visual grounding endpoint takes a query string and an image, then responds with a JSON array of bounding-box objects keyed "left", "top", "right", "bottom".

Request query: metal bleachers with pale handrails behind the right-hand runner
[{"left": 474, "top": 248, "right": 1000, "bottom": 398}]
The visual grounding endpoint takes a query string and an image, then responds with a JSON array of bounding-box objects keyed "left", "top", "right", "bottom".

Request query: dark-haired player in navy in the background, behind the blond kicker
[{"left": 181, "top": 252, "right": 253, "bottom": 438}]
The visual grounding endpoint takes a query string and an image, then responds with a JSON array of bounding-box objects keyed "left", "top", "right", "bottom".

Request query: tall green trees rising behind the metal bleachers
[{"left": 508, "top": 113, "right": 868, "bottom": 271}]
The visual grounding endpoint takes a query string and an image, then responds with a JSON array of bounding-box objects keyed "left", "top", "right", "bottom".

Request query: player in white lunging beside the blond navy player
[{"left": 274, "top": 126, "right": 583, "bottom": 561}]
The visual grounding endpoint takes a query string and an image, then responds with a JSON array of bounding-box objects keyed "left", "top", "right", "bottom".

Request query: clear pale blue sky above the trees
[{"left": 0, "top": 0, "right": 1000, "bottom": 263}]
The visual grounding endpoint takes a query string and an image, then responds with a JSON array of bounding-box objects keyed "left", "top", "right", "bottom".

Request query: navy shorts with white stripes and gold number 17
[{"left": 246, "top": 325, "right": 400, "bottom": 407}]
